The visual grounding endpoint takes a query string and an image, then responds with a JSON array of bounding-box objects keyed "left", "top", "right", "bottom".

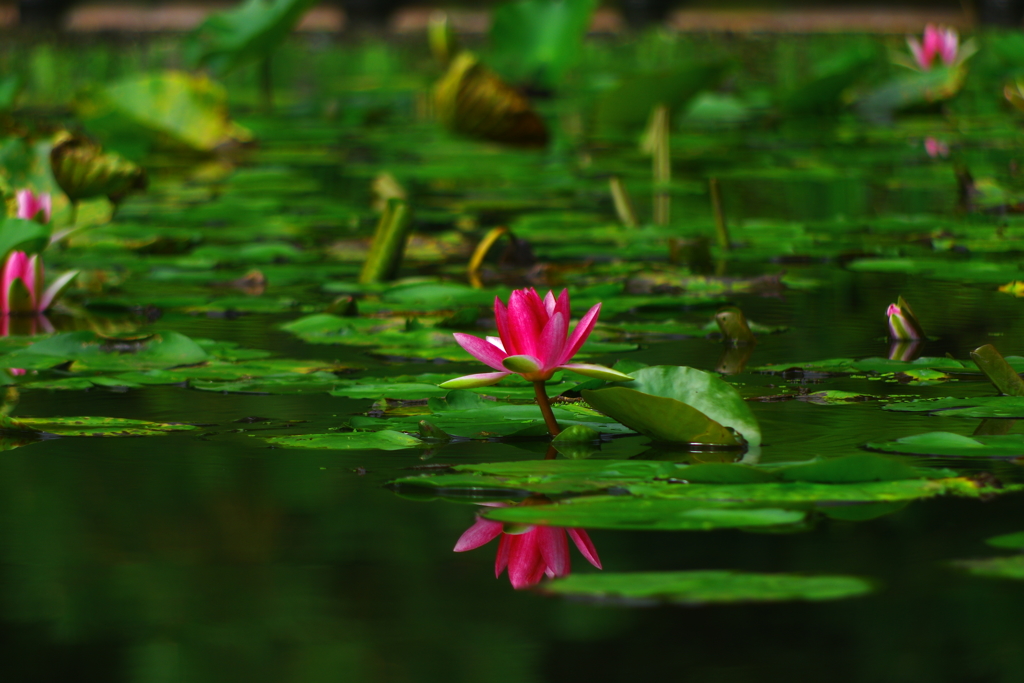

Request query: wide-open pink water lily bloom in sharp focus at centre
[{"left": 440, "top": 288, "right": 633, "bottom": 389}]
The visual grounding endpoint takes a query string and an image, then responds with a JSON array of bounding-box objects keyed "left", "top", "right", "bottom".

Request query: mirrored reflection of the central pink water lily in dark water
[{"left": 455, "top": 503, "right": 601, "bottom": 589}]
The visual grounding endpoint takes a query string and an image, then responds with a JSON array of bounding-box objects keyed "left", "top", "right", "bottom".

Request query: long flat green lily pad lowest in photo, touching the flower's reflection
[{"left": 541, "top": 570, "right": 874, "bottom": 605}]
